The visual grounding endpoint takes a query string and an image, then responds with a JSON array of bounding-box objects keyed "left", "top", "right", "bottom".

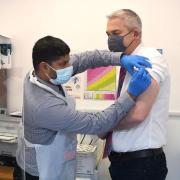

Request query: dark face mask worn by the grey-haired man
[{"left": 108, "top": 31, "right": 132, "bottom": 52}]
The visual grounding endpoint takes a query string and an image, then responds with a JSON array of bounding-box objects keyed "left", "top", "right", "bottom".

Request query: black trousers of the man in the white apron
[{"left": 14, "top": 166, "right": 39, "bottom": 180}]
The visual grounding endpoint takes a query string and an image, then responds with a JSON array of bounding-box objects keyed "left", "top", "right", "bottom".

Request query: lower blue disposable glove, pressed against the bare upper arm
[{"left": 128, "top": 68, "right": 151, "bottom": 96}]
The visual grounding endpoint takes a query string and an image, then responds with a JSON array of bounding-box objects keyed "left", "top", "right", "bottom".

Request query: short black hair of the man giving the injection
[{"left": 32, "top": 36, "right": 70, "bottom": 71}]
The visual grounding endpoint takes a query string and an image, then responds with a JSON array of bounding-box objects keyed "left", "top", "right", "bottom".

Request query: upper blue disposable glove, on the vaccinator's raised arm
[{"left": 120, "top": 55, "right": 152, "bottom": 75}]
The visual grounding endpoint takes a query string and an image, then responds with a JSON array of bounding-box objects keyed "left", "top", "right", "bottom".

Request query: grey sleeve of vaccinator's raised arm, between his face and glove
[{"left": 70, "top": 50, "right": 122, "bottom": 75}]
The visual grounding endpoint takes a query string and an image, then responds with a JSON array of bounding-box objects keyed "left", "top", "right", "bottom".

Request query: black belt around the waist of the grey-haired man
[{"left": 109, "top": 148, "right": 163, "bottom": 162}]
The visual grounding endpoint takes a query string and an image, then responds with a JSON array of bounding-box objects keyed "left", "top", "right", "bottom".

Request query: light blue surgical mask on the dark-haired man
[{"left": 48, "top": 64, "right": 73, "bottom": 85}]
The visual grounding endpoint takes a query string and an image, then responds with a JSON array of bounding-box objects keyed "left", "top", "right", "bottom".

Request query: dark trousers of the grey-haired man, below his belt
[{"left": 109, "top": 153, "right": 168, "bottom": 180}]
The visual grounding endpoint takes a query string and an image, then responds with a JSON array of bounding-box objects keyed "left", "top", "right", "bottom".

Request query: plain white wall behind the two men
[{"left": 0, "top": 0, "right": 180, "bottom": 180}]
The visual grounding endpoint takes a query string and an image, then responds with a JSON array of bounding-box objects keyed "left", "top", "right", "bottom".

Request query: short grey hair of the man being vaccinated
[{"left": 107, "top": 9, "right": 142, "bottom": 32}]
